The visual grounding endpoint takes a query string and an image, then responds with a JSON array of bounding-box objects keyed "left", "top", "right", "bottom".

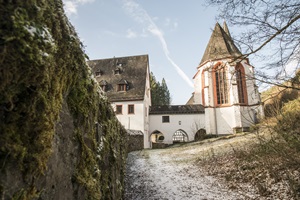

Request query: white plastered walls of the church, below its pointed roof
[{"left": 194, "top": 59, "right": 263, "bottom": 134}]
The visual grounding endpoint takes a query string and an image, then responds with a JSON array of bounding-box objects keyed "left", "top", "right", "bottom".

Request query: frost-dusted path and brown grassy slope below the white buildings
[{"left": 125, "top": 129, "right": 298, "bottom": 200}]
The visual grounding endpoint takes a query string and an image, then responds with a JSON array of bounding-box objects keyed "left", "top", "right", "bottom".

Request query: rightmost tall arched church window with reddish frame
[{"left": 235, "top": 64, "right": 247, "bottom": 104}]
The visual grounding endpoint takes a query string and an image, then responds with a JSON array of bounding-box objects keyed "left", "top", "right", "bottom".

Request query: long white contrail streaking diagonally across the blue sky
[{"left": 123, "top": 0, "right": 194, "bottom": 88}]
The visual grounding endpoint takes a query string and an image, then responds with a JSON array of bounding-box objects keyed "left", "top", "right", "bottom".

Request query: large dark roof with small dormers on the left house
[{"left": 88, "top": 55, "right": 149, "bottom": 102}]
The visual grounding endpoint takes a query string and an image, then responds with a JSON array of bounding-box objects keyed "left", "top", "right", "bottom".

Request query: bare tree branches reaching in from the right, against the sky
[{"left": 206, "top": 0, "right": 300, "bottom": 89}]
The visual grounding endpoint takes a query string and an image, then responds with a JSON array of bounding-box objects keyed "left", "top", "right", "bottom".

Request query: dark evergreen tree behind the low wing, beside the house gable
[{"left": 150, "top": 72, "right": 171, "bottom": 105}]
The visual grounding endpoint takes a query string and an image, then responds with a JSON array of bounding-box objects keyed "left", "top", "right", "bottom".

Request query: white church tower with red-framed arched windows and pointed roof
[{"left": 192, "top": 22, "right": 263, "bottom": 135}]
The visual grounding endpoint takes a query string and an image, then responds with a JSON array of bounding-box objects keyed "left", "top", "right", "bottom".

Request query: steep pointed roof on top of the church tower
[{"left": 200, "top": 22, "right": 242, "bottom": 65}]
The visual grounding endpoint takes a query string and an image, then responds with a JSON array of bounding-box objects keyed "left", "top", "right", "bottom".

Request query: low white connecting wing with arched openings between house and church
[{"left": 150, "top": 105, "right": 205, "bottom": 144}]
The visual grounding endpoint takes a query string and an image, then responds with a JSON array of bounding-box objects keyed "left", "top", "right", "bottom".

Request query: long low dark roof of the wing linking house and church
[{"left": 149, "top": 104, "right": 204, "bottom": 115}]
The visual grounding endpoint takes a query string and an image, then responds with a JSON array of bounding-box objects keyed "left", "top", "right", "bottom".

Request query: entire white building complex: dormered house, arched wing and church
[{"left": 89, "top": 23, "right": 263, "bottom": 148}]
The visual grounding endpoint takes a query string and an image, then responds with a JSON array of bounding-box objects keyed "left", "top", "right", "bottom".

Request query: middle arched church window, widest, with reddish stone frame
[{"left": 213, "top": 64, "right": 229, "bottom": 105}]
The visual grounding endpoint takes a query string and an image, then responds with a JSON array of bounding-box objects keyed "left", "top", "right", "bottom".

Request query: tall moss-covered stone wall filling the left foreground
[{"left": 0, "top": 0, "right": 127, "bottom": 199}]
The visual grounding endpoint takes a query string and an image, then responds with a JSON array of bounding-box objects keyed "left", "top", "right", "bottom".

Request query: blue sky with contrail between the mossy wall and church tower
[{"left": 63, "top": 0, "right": 219, "bottom": 105}]
